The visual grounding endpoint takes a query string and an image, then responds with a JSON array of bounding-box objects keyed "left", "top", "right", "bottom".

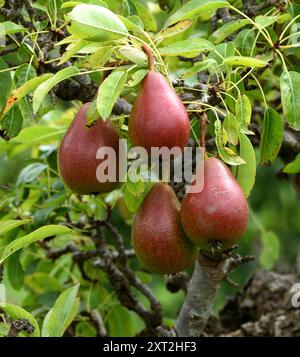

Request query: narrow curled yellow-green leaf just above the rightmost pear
[{"left": 215, "top": 119, "right": 245, "bottom": 166}]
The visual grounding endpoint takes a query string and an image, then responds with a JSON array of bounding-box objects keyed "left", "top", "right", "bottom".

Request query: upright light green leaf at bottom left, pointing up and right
[{"left": 42, "top": 284, "right": 79, "bottom": 337}]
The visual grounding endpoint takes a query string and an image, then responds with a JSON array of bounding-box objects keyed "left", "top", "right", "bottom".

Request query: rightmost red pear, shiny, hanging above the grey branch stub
[{"left": 180, "top": 157, "right": 248, "bottom": 249}]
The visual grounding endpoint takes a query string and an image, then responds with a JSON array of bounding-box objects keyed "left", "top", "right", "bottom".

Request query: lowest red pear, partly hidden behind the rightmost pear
[{"left": 132, "top": 183, "right": 197, "bottom": 274}]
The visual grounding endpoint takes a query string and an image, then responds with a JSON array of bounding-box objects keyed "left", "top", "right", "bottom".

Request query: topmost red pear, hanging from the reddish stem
[{"left": 129, "top": 71, "right": 190, "bottom": 153}]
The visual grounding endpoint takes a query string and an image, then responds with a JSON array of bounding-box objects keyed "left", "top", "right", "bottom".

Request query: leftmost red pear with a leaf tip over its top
[{"left": 58, "top": 103, "right": 119, "bottom": 195}]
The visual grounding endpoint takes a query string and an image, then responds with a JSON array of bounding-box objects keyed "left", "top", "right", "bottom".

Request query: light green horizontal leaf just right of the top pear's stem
[{"left": 158, "top": 38, "right": 214, "bottom": 57}]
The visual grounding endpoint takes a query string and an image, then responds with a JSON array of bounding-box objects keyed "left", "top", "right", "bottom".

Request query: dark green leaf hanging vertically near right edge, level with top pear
[{"left": 260, "top": 108, "right": 284, "bottom": 165}]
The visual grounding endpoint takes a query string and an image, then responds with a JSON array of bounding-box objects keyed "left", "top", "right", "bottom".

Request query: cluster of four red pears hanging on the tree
[{"left": 58, "top": 46, "right": 248, "bottom": 274}]
